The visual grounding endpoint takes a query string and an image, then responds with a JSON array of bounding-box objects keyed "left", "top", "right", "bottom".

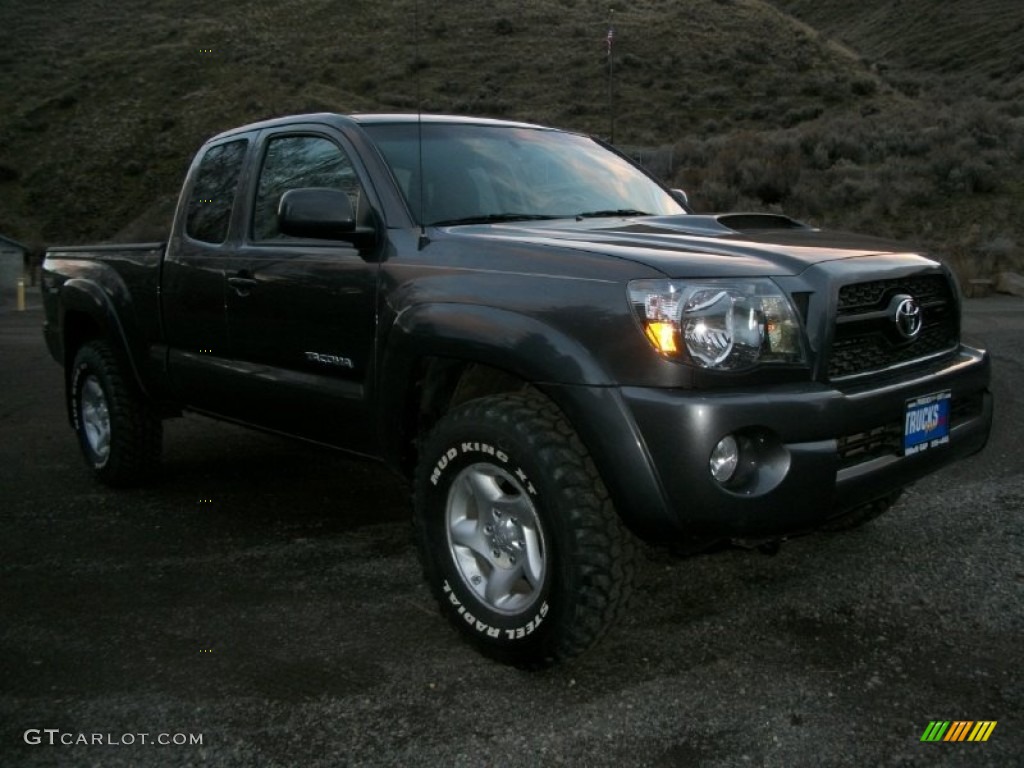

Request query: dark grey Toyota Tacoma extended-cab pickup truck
[{"left": 42, "top": 114, "right": 992, "bottom": 666}]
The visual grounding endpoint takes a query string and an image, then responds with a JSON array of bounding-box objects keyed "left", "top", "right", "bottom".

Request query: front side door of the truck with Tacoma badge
[{"left": 220, "top": 127, "right": 378, "bottom": 450}]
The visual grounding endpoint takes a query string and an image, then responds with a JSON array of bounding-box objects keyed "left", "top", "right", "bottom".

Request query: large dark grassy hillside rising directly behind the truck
[{"left": 0, "top": 0, "right": 1024, "bottom": 280}]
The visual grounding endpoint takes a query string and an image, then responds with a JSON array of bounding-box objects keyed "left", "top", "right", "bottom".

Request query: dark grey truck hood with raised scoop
[{"left": 450, "top": 213, "right": 912, "bottom": 278}]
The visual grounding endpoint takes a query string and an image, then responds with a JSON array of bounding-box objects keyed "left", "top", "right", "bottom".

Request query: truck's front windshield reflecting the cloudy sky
[{"left": 362, "top": 123, "right": 685, "bottom": 226}]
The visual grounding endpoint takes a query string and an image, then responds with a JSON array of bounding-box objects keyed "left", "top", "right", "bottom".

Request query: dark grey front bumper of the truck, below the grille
[{"left": 598, "top": 346, "right": 992, "bottom": 538}]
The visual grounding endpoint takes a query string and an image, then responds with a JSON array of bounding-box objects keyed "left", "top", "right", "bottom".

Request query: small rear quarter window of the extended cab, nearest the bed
[{"left": 185, "top": 139, "right": 248, "bottom": 243}]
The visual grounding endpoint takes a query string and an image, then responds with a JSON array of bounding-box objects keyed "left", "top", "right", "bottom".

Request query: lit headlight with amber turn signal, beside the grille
[{"left": 630, "top": 279, "right": 804, "bottom": 371}]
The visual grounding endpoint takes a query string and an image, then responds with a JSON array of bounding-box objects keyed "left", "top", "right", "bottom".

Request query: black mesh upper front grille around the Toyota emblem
[{"left": 828, "top": 274, "right": 959, "bottom": 379}]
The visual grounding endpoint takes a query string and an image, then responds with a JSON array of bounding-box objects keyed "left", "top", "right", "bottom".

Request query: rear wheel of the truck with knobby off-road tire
[{"left": 69, "top": 340, "right": 163, "bottom": 487}]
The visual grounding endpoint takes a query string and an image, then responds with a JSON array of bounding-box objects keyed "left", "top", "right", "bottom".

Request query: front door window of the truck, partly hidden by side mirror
[{"left": 252, "top": 136, "right": 361, "bottom": 241}]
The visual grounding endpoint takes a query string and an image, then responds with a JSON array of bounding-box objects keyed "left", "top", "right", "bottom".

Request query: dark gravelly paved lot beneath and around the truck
[{"left": 0, "top": 298, "right": 1024, "bottom": 766}]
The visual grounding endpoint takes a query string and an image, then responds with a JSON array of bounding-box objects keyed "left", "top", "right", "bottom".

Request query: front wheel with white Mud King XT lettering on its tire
[{"left": 414, "top": 393, "right": 634, "bottom": 667}]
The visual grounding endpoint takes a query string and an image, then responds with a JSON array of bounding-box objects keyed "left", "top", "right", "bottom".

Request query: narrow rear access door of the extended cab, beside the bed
[{"left": 161, "top": 138, "right": 250, "bottom": 414}]
